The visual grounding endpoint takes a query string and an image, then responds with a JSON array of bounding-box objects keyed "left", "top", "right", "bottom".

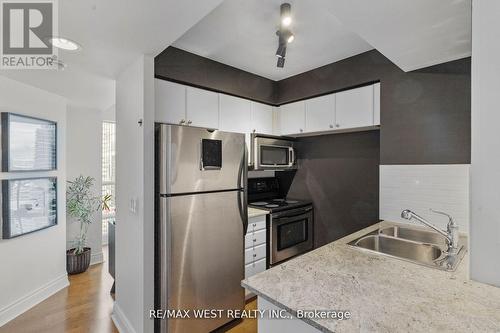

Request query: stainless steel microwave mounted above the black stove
[{"left": 250, "top": 133, "right": 297, "bottom": 170}]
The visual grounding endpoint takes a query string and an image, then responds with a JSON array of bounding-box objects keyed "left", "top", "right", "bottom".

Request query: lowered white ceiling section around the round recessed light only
[{"left": 55, "top": 0, "right": 222, "bottom": 78}]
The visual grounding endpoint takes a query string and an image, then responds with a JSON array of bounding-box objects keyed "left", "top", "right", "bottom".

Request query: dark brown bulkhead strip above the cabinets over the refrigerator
[{"left": 155, "top": 47, "right": 276, "bottom": 105}]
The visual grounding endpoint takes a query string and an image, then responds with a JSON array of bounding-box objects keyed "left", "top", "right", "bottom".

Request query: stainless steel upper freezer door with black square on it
[{"left": 156, "top": 124, "right": 247, "bottom": 194}]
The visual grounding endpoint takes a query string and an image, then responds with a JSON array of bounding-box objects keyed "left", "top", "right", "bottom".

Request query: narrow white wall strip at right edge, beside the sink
[{"left": 470, "top": 0, "right": 500, "bottom": 286}]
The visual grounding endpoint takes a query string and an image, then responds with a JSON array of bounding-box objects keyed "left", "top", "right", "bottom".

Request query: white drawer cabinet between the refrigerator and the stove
[{"left": 245, "top": 215, "right": 267, "bottom": 299}]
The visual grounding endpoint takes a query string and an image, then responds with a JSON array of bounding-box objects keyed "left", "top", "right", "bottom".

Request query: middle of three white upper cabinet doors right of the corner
[{"left": 305, "top": 94, "right": 335, "bottom": 132}]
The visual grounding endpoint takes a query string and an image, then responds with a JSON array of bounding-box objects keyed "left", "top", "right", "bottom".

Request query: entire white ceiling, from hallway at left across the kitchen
[{"left": 0, "top": 0, "right": 471, "bottom": 109}]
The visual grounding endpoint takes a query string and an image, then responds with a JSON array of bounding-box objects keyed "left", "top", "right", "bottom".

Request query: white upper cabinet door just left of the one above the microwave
[{"left": 219, "top": 94, "right": 252, "bottom": 133}]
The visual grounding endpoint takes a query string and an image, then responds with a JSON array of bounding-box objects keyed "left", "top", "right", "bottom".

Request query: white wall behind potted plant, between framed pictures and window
[{"left": 66, "top": 105, "right": 103, "bottom": 264}]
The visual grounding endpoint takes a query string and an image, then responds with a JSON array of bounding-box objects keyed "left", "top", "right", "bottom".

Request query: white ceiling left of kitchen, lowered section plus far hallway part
[{"left": 0, "top": 0, "right": 222, "bottom": 109}]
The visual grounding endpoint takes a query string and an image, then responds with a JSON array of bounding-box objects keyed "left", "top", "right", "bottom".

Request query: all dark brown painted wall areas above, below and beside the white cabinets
[{"left": 155, "top": 48, "right": 471, "bottom": 246}]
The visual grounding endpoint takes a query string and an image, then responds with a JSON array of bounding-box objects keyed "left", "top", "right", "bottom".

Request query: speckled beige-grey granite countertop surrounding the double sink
[{"left": 242, "top": 221, "right": 500, "bottom": 332}]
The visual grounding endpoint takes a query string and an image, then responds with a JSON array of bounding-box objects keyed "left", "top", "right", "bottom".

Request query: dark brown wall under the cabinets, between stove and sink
[{"left": 276, "top": 131, "right": 380, "bottom": 247}]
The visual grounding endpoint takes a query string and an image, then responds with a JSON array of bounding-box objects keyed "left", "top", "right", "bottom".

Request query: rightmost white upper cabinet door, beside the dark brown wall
[{"left": 335, "top": 85, "right": 374, "bottom": 129}]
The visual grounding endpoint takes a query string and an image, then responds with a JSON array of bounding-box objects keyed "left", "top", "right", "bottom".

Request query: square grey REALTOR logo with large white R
[{"left": 0, "top": 0, "right": 57, "bottom": 69}]
